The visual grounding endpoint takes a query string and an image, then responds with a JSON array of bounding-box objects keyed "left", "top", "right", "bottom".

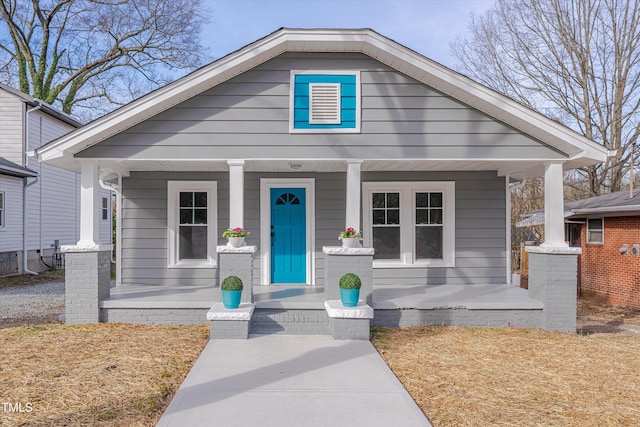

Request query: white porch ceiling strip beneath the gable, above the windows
[{"left": 99, "top": 159, "right": 544, "bottom": 180}]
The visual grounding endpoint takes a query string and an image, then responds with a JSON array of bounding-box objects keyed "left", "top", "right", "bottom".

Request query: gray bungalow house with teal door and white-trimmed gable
[{"left": 37, "top": 29, "right": 608, "bottom": 333}]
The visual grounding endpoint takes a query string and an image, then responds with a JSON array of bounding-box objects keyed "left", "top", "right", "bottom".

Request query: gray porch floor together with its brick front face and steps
[{"left": 100, "top": 284, "right": 543, "bottom": 334}]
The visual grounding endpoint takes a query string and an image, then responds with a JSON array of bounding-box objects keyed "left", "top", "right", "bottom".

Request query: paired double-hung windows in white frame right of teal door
[{"left": 363, "top": 182, "right": 455, "bottom": 267}]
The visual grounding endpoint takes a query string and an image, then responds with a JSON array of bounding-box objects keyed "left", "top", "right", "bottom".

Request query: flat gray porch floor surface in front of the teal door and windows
[{"left": 100, "top": 284, "right": 542, "bottom": 310}]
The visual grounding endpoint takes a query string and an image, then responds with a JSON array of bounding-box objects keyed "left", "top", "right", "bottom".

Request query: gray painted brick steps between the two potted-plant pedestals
[{"left": 249, "top": 308, "right": 331, "bottom": 335}]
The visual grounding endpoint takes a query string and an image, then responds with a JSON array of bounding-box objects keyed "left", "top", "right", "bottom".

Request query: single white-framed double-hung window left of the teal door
[{"left": 167, "top": 181, "right": 218, "bottom": 268}]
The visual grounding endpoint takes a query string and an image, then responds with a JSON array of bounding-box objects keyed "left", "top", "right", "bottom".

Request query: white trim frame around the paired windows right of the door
[{"left": 362, "top": 181, "right": 456, "bottom": 268}]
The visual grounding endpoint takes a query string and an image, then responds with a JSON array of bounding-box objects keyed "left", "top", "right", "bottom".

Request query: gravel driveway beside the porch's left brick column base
[{"left": 0, "top": 282, "right": 64, "bottom": 328}]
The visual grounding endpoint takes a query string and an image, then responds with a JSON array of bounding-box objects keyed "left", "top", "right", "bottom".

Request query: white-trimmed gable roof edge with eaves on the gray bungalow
[{"left": 37, "top": 28, "right": 608, "bottom": 177}]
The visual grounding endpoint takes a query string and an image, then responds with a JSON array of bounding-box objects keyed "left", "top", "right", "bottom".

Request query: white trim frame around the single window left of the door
[{"left": 167, "top": 181, "right": 218, "bottom": 268}]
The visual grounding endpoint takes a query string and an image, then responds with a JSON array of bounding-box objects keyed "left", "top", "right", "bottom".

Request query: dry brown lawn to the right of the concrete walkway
[{"left": 372, "top": 326, "right": 640, "bottom": 427}]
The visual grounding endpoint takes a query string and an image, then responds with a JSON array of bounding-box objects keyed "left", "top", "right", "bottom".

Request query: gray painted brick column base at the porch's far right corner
[{"left": 526, "top": 246, "right": 581, "bottom": 332}]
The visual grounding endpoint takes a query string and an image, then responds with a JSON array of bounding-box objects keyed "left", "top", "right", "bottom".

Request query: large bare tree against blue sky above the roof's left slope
[{"left": 0, "top": 0, "right": 207, "bottom": 116}]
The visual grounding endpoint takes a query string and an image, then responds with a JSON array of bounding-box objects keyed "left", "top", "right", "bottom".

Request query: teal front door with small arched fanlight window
[{"left": 271, "top": 188, "right": 307, "bottom": 283}]
